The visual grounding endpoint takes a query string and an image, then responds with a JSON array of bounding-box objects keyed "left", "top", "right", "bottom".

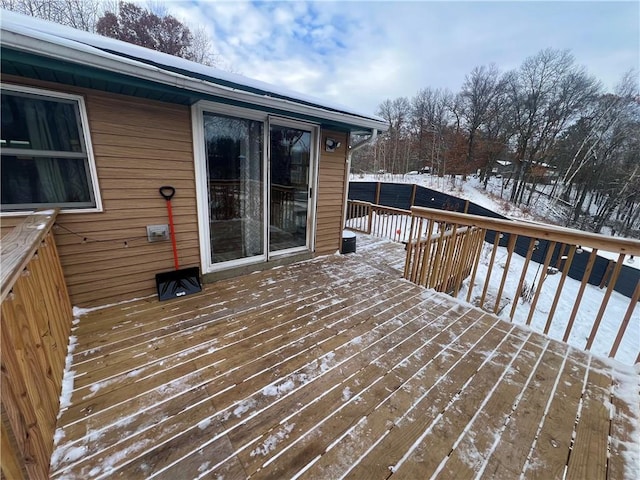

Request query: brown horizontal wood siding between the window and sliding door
[{"left": 2, "top": 76, "right": 200, "bottom": 306}]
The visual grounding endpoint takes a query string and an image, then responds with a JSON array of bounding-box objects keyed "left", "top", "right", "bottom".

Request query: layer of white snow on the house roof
[{"left": 0, "top": 10, "right": 386, "bottom": 129}]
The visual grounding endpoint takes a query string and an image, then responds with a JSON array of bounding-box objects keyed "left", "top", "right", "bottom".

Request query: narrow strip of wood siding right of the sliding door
[{"left": 316, "top": 130, "right": 348, "bottom": 255}]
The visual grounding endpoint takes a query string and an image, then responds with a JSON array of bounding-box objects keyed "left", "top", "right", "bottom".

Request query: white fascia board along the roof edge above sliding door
[{"left": 1, "top": 28, "right": 388, "bottom": 131}]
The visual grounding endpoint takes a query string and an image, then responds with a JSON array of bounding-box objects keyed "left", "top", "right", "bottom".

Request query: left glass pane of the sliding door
[{"left": 203, "top": 112, "right": 266, "bottom": 264}]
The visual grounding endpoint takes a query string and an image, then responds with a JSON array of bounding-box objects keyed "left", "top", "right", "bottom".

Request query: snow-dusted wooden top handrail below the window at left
[{"left": 0, "top": 209, "right": 59, "bottom": 301}]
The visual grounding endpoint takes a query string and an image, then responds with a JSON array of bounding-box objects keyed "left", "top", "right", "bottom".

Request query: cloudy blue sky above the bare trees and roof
[{"left": 167, "top": 0, "right": 640, "bottom": 114}]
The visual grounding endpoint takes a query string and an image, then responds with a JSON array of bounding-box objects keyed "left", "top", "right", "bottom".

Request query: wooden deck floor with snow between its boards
[{"left": 51, "top": 237, "right": 640, "bottom": 480}]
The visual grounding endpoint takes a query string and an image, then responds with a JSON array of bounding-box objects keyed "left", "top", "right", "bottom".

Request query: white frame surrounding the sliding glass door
[{"left": 191, "top": 100, "right": 320, "bottom": 274}]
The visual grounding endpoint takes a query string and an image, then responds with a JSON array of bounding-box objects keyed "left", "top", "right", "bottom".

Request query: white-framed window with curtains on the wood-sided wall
[{"left": 0, "top": 85, "right": 100, "bottom": 213}]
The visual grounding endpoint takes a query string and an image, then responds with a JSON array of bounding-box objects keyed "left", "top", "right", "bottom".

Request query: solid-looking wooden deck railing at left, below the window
[{"left": 0, "top": 210, "right": 73, "bottom": 479}]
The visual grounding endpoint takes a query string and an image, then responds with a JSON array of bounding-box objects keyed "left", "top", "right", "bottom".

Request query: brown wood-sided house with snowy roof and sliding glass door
[{"left": 0, "top": 11, "right": 386, "bottom": 305}]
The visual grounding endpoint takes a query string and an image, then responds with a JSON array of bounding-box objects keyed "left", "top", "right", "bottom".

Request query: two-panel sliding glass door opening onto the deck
[{"left": 194, "top": 106, "right": 317, "bottom": 273}]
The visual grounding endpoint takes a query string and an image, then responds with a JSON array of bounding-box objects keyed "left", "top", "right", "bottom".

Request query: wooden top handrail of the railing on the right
[{"left": 411, "top": 207, "right": 640, "bottom": 256}]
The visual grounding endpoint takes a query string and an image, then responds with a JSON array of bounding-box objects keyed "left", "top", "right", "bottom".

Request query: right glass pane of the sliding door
[{"left": 269, "top": 125, "right": 312, "bottom": 252}]
